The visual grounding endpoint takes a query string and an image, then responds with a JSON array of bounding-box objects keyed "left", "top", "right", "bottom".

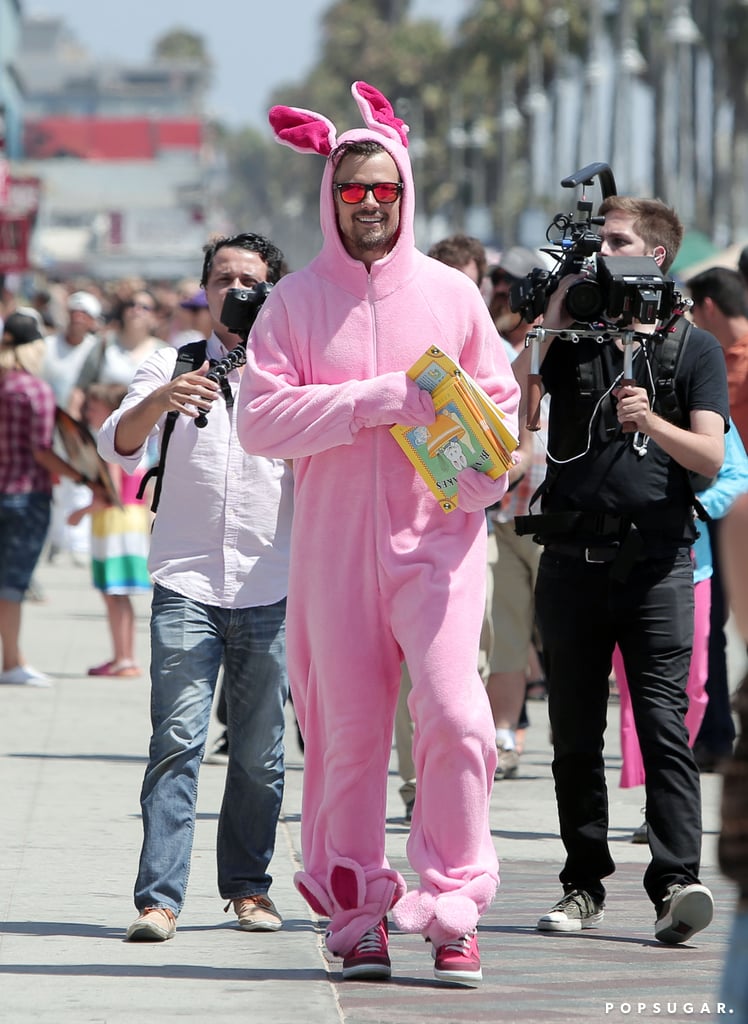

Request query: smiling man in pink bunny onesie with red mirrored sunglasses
[{"left": 238, "top": 82, "right": 518, "bottom": 985}]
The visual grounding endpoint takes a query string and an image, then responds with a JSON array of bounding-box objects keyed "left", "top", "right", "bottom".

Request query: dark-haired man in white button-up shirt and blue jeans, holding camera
[{"left": 98, "top": 233, "right": 292, "bottom": 941}]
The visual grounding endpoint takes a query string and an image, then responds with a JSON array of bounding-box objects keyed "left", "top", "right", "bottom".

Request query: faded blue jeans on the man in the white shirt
[{"left": 135, "top": 584, "right": 288, "bottom": 914}]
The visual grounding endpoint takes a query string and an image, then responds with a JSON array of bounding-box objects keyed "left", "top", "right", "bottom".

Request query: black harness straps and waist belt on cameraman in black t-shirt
[{"left": 514, "top": 313, "right": 711, "bottom": 581}]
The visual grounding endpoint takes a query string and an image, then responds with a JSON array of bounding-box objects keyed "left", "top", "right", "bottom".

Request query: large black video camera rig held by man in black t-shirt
[{"left": 509, "top": 164, "right": 677, "bottom": 326}]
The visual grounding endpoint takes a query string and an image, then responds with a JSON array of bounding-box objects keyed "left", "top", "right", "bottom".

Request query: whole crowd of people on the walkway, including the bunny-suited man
[{"left": 0, "top": 82, "right": 748, "bottom": 1007}]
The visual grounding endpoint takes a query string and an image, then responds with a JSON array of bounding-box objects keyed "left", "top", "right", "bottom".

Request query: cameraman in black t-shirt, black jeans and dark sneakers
[{"left": 513, "top": 196, "right": 729, "bottom": 943}]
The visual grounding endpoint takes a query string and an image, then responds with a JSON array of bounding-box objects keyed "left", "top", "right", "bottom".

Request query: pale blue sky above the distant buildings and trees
[{"left": 27, "top": 0, "right": 461, "bottom": 127}]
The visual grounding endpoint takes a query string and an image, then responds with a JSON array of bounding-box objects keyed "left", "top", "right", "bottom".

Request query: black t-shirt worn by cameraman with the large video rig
[{"left": 541, "top": 328, "right": 730, "bottom": 541}]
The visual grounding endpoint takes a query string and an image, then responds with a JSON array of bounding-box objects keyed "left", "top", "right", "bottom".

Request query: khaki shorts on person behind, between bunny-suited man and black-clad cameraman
[{"left": 489, "top": 522, "right": 542, "bottom": 672}]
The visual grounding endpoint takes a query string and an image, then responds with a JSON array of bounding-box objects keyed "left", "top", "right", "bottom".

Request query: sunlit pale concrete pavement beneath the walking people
[{"left": 0, "top": 559, "right": 733, "bottom": 1024}]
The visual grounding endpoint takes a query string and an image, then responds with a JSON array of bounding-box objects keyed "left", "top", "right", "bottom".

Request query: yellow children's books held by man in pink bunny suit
[{"left": 389, "top": 346, "right": 517, "bottom": 512}]
